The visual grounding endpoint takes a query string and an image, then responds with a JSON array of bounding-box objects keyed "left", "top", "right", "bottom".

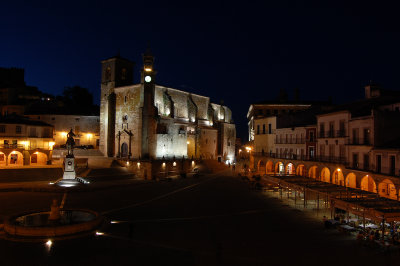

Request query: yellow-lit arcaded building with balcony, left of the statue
[{"left": 0, "top": 116, "right": 54, "bottom": 166}]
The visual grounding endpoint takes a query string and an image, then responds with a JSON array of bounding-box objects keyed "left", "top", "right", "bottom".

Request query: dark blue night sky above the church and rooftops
[{"left": 0, "top": 1, "right": 400, "bottom": 139}]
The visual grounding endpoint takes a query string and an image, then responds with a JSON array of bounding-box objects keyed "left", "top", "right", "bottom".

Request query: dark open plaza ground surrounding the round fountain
[{"left": 0, "top": 165, "right": 399, "bottom": 265}]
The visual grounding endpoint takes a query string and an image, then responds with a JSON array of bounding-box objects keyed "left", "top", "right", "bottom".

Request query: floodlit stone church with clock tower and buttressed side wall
[{"left": 99, "top": 49, "right": 236, "bottom": 161}]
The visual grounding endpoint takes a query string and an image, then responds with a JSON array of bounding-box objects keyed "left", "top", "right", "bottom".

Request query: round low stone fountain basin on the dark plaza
[{"left": 4, "top": 209, "right": 103, "bottom": 238}]
